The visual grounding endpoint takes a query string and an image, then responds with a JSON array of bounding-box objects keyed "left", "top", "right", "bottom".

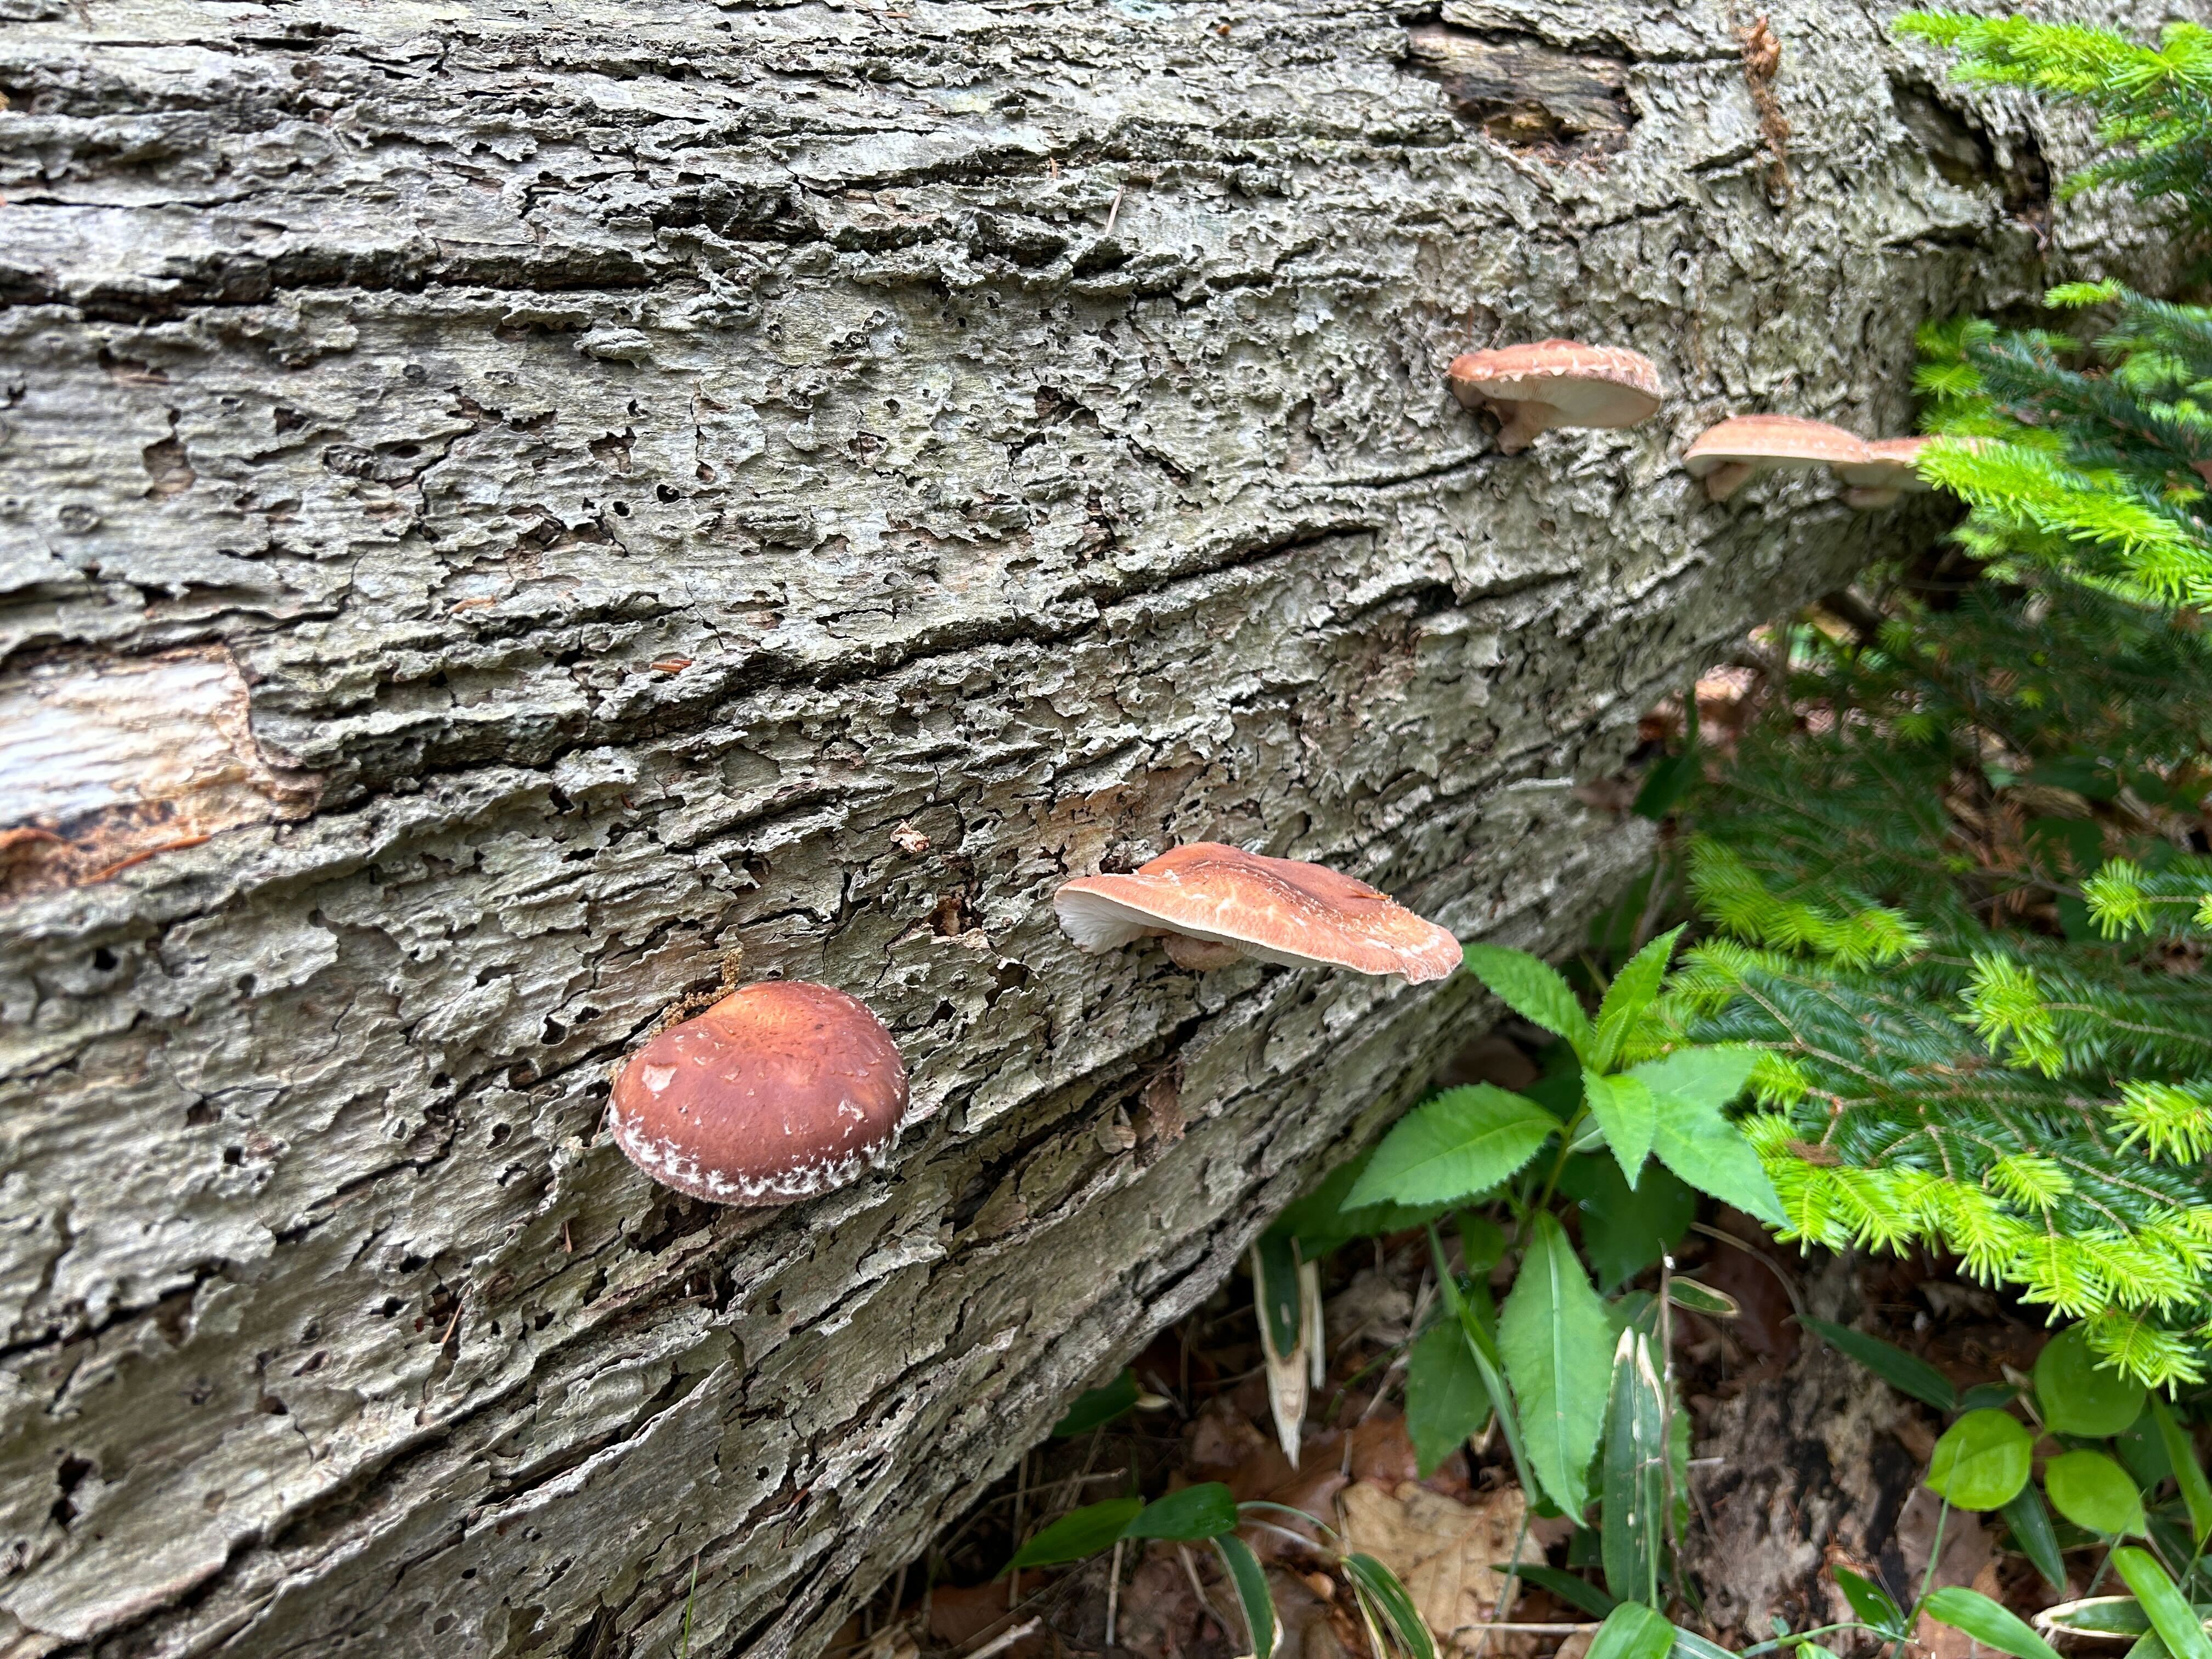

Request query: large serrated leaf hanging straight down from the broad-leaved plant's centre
[{"left": 1498, "top": 1210, "right": 1610, "bottom": 1526}]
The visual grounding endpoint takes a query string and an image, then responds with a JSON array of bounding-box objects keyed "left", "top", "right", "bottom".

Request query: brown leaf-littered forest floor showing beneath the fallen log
[{"left": 832, "top": 1035, "right": 2092, "bottom": 1659}]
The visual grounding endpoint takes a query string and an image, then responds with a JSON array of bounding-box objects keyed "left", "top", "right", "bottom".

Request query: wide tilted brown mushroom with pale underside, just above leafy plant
[{"left": 1053, "top": 840, "right": 1460, "bottom": 984}]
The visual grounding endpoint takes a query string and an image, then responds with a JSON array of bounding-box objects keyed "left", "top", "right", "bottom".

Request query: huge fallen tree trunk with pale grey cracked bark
[{"left": 0, "top": 0, "right": 2135, "bottom": 1659}]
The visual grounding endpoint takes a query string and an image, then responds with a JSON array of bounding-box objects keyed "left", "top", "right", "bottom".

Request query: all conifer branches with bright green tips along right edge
[{"left": 1666, "top": 13, "right": 2212, "bottom": 1385}]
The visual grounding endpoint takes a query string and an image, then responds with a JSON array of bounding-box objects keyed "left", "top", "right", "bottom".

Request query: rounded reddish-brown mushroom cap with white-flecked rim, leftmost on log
[{"left": 608, "top": 980, "right": 907, "bottom": 1203}]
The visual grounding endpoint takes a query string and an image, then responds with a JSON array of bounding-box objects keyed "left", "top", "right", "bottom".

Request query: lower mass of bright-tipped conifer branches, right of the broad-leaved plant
[{"left": 1663, "top": 575, "right": 2212, "bottom": 1383}]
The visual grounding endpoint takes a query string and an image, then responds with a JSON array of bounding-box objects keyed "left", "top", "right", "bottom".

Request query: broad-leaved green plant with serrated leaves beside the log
[{"left": 1254, "top": 929, "right": 1781, "bottom": 1641}]
